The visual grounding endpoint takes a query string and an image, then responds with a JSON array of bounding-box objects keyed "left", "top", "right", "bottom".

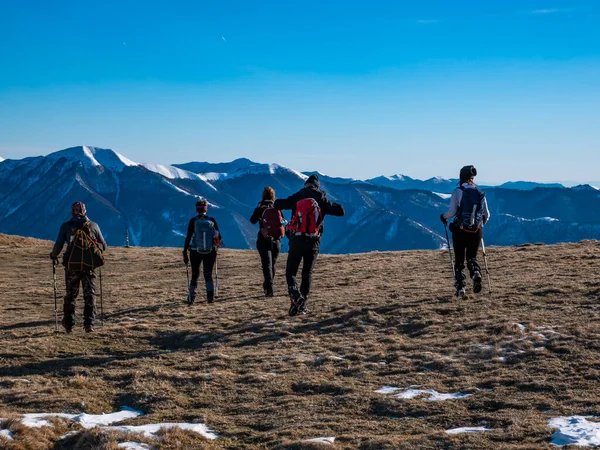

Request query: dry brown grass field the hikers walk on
[{"left": 0, "top": 235, "right": 600, "bottom": 450}]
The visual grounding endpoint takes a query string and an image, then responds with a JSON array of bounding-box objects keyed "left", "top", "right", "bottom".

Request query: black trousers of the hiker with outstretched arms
[{"left": 285, "top": 236, "right": 319, "bottom": 299}]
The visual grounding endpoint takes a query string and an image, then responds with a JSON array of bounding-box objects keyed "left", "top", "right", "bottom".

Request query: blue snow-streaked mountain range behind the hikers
[{"left": 0, "top": 146, "right": 600, "bottom": 253}]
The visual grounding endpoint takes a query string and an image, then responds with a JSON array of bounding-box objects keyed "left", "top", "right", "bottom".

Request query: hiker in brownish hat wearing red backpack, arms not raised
[{"left": 250, "top": 186, "right": 285, "bottom": 297}]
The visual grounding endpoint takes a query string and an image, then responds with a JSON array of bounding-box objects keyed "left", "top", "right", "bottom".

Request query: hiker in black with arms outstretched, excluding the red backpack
[{"left": 275, "top": 174, "right": 344, "bottom": 316}]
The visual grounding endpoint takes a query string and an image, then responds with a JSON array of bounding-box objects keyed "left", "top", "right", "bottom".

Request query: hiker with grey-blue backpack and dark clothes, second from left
[{"left": 183, "top": 199, "right": 221, "bottom": 305}]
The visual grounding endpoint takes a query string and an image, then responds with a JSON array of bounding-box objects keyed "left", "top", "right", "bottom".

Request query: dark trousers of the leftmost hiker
[{"left": 63, "top": 269, "right": 96, "bottom": 328}]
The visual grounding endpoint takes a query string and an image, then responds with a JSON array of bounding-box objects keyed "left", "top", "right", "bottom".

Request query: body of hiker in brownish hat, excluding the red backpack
[{"left": 250, "top": 186, "right": 283, "bottom": 297}]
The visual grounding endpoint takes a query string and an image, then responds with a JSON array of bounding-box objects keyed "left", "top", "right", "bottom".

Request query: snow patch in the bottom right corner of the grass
[{"left": 548, "top": 416, "right": 600, "bottom": 447}]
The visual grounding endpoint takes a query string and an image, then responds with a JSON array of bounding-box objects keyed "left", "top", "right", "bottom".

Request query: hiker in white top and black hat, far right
[{"left": 440, "top": 166, "right": 490, "bottom": 297}]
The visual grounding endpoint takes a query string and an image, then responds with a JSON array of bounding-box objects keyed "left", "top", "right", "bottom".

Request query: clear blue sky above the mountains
[{"left": 0, "top": 0, "right": 600, "bottom": 182}]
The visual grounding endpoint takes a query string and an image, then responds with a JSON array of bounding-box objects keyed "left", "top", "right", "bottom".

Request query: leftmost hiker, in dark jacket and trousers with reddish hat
[{"left": 50, "top": 202, "right": 106, "bottom": 333}]
